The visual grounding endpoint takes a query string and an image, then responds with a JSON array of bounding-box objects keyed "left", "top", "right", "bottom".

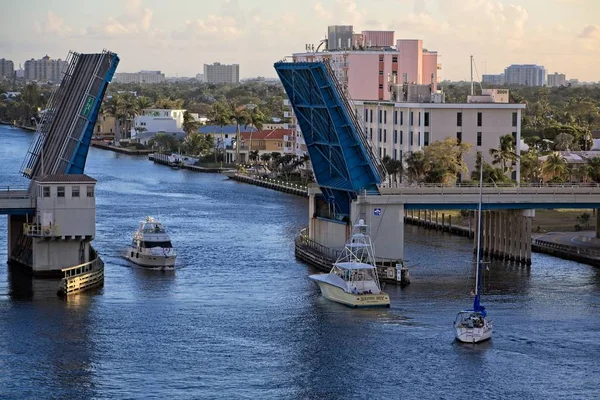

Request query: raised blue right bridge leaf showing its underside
[{"left": 275, "top": 62, "right": 386, "bottom": 215}]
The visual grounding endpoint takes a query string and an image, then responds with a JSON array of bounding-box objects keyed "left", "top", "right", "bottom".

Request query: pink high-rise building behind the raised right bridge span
[{"left": 293, "top": 37, "right": 440, "bottom": 100}]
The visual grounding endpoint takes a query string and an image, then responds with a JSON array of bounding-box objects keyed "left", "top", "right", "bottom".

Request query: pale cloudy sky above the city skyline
[{"left": 0, "top": 0, "right": 600, "bottom": 81}]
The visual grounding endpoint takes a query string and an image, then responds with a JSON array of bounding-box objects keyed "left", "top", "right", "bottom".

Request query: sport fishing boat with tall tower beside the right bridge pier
[{"left": 309, "top": 219, "right": 390, "bottom": 308}]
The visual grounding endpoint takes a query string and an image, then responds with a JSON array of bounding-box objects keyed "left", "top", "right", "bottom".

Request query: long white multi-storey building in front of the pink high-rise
[{"left": 354, "top": 89, "right": 525, "bottom": 180}]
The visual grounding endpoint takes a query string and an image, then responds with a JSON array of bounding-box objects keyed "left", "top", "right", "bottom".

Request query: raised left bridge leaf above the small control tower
[{"left": 21, "top": 50, "right": 119, "bottom": 178}]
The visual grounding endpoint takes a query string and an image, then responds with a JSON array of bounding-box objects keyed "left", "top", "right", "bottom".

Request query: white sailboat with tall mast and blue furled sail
[{"left": 454, "top": 155, "right": 492, "bottom": 343}]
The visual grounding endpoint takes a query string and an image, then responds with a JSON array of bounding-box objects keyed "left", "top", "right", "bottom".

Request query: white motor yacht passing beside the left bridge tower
[{"left": 124, "top": 217, "right": 177, "bottom": 269}]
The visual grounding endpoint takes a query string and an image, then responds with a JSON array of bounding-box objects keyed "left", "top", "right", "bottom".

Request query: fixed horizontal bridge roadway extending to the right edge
[{"left": 378, "top": 183, "right": 600, "bottom": 210}]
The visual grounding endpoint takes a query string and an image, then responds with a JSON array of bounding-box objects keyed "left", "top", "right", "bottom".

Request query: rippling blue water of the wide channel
[{"left": 0, "top": 127, "right": 600, "bottom": 399}]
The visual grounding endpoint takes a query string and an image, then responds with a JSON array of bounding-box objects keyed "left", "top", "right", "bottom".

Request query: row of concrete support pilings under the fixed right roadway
[{"left": 473, "top": 210, "right": 535, "bottom": 265}]
